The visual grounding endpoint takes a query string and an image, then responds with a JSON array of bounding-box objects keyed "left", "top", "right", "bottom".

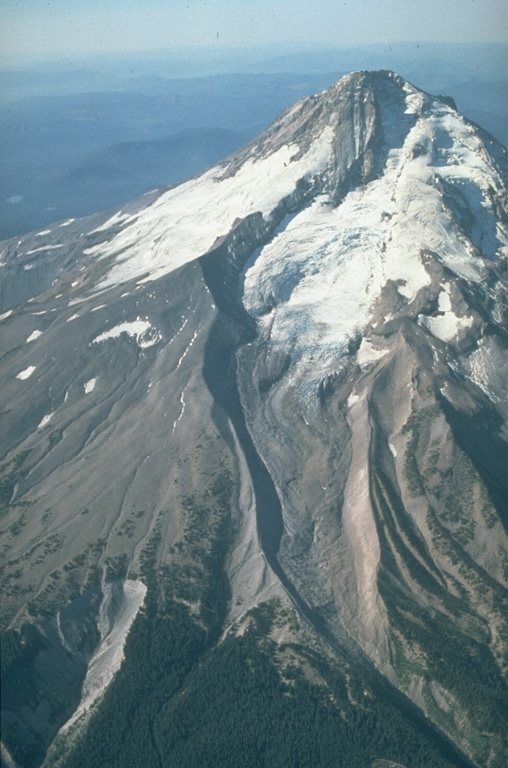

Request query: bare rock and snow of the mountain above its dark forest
[{"left": 1, "top": 72, "right": 508, "bottom": 766}]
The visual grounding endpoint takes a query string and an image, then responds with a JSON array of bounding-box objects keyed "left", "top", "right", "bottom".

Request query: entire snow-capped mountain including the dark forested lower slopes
[{"left": 0, "top": 72, "right": 508, "bottom": 768}]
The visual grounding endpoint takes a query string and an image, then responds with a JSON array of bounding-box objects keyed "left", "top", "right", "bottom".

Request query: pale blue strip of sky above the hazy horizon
[{"left": 0, "top": 0, "right": 507, "bottom": 60}]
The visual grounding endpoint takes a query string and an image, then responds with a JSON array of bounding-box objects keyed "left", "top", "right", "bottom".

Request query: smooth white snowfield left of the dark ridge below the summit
[{"left": 85, "top": 130, "right": 333, "bottom": 289}]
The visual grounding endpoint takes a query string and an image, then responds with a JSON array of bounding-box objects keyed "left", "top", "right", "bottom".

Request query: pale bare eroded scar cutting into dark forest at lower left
[{"left": 61, "top": 580, "right": 146, "bottom": 732}]
